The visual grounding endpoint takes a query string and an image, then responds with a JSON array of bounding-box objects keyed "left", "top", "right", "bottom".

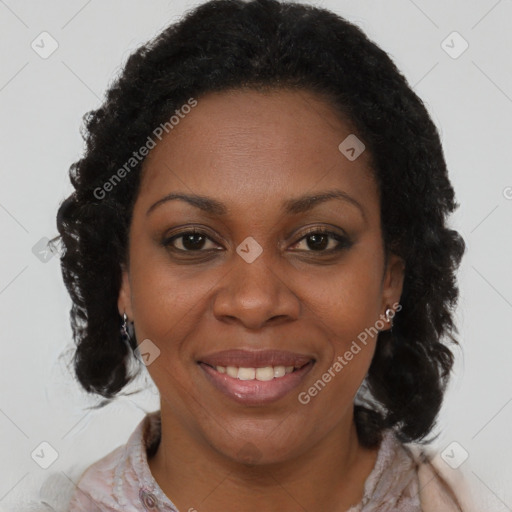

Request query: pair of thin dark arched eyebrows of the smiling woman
[{"left": 146, "top": 189, "right": 366, "bottom": 221}]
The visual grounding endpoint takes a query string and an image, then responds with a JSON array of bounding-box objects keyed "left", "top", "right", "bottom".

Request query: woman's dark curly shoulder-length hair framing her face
[{"left": 54, "top": 0, "right": 465, "bottom": 447}]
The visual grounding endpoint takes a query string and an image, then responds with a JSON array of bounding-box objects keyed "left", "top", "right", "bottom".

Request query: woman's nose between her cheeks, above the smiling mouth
[{"left": 213, "top": 245, "right": 301, "bottom": 330}]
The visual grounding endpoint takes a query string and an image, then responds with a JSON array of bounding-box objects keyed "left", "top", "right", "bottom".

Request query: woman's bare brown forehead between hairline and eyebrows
[{"left": 139, "top": 90, "right": 377, "bottom": 214}]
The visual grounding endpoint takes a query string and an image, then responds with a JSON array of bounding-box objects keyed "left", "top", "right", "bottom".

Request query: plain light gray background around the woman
[{"left": 0, "top": 0, "right": 512, "bottom": 512}]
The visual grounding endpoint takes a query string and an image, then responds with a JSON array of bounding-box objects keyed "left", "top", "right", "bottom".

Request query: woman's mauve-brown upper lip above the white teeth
[{"left": 198, "top": 349, "right": 314, "bottom": 368}]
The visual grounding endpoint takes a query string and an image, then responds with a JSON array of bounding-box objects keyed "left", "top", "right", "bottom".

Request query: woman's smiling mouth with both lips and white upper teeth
[{"left": 197, "top": 350, "right": 315, "bottom": 406}]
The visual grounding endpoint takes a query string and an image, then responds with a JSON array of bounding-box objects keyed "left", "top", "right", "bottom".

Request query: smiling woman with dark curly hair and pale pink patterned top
[{"left": 49, "top": 0, "right": 480, "bottom": 512}]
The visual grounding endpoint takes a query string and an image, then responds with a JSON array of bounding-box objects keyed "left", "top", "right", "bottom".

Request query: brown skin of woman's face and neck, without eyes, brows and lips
[{"left": 118, "top": 90, "right": 404, "bottom": 512}]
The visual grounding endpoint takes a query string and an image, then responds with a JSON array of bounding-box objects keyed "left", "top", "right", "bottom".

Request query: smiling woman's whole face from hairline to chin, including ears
[{"left": 119, "top": 90, "right": 403, "bottom": 463}]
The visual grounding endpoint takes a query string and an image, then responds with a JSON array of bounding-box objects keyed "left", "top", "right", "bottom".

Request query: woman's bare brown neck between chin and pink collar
[{"left": 148, "top": 401, "right": 378, "bottom": 512}]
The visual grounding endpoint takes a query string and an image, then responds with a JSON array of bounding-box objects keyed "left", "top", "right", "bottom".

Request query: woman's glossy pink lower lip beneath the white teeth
[{"left": 199, "top": 361, "right": 314, "bottom": 405}]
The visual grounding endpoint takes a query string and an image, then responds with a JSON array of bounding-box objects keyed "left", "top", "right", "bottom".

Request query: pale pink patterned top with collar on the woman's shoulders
[{"left": 69, "top": 411, "right": 462, "bottom": 512}]
